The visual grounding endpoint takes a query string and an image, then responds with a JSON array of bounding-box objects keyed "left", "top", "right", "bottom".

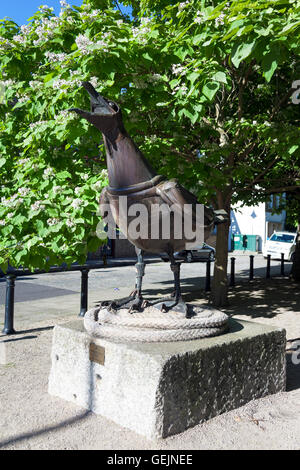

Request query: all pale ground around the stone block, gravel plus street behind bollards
[{"left": 0, "top": 255, "right": 300, "bottom": 450}]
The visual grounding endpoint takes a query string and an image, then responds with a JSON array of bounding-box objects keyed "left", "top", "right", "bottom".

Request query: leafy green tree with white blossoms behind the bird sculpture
[{"left": 0, "top": 0, "right": 300, "bottom": 305}]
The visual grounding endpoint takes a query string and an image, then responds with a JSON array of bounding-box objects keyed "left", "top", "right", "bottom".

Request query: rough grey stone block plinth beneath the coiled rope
[{"left": 49, "top": 320, "right": 285, "bottom": 439}]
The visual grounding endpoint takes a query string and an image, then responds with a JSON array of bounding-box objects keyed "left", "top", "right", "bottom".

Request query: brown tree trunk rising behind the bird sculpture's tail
[{"left": 211, "top": 198, "right": 230, "bottom": 307}]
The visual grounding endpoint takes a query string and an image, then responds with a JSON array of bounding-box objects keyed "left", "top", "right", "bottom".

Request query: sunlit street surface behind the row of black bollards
[{"left": 0, "top": 255, "right": 291, "bottom": 330}]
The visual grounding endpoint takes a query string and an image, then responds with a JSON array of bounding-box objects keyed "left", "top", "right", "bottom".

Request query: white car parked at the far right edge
[{"left": 263, "top": 232, "right": 297, "bottom": 261}]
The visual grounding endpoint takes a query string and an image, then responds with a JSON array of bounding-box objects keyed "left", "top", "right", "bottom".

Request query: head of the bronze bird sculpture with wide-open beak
[{"left": 69, "top": 82, "right": 124, "bottom": 142}]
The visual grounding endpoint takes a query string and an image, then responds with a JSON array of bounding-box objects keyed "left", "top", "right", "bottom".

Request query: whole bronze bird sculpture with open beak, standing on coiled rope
[{"left": 70, "top": 82, "right": 226, "bottom": 313}]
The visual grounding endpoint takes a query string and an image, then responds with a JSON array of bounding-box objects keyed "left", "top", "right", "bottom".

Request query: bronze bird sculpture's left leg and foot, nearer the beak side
[{"left": 100, "top": 249, "right": 145, "bottom": 312}]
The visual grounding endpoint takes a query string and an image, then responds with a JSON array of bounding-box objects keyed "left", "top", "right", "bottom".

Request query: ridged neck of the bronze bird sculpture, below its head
[{"left": 104, "top": 132, "right": 157, "bottom": 189}]
